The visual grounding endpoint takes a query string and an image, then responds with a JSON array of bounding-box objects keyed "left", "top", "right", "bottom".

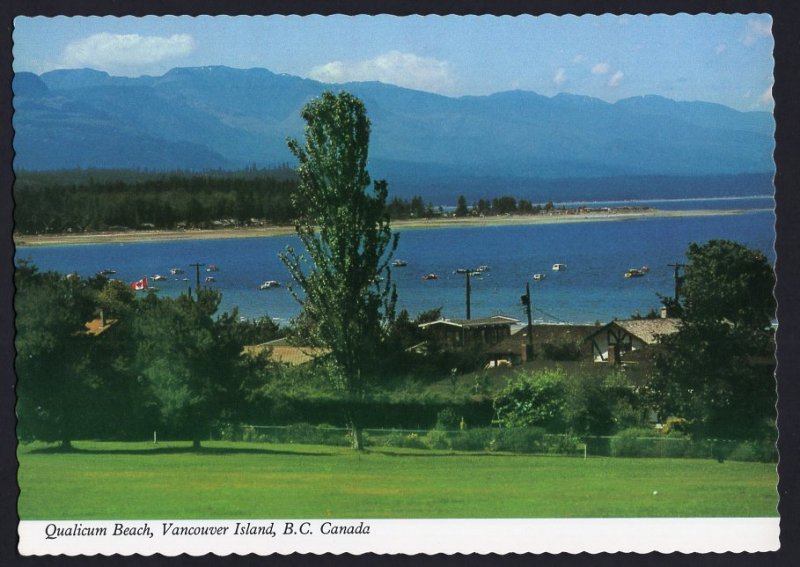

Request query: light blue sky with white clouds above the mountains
[{"left": 13, "top": 14, "right": 774, "bottom": 111}]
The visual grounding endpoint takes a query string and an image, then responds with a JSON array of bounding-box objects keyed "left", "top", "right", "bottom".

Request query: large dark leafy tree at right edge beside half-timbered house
[{"left": 656, "top": 240, "right": 775, "bottom": 438}]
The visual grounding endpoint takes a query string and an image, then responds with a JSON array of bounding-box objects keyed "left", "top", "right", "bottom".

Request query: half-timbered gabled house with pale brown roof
[{"left": 586, "top": 317, "right": 680, "bottom": 364}]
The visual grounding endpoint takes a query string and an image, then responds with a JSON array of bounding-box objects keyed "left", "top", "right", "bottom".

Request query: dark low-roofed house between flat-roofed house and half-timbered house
[{"left": 486, "top": 324, "right": 597, "bottom": 366}]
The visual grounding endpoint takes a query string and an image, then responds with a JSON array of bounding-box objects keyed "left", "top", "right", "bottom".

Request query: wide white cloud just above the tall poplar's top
[{"left": 308, "top": 51, "right": 456, "bottom": 94}]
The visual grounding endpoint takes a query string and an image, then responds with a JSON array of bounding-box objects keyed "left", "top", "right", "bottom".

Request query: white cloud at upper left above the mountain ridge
[{"left": 62, "top": 33, "right": 195, "bottom": 71}]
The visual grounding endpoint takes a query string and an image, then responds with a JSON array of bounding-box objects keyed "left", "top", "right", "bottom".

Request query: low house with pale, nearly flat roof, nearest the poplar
[{"left": 419, "top": 315, "right": 520, "bottom": 348}]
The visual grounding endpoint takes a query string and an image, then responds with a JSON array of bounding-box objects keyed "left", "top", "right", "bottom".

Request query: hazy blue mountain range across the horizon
[{"left": 13, "top": 67, "right": 774, "bottom": 197}]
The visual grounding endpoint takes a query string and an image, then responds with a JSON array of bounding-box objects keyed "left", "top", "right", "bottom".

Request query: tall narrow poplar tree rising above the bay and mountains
[{"left": 281, "top": 92, "right": 397, "bottom": 450}]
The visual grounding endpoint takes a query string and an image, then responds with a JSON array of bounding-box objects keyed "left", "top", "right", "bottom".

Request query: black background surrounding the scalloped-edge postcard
[{"left": 0, "top": 0, "right": 800, "bottom": 566}]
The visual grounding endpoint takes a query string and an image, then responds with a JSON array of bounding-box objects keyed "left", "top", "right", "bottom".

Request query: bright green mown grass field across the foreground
[{"left": 18, "top": 442, "right": 778, "bottom": 520}]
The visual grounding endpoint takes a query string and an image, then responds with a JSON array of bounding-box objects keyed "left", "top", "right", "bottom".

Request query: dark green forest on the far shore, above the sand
[{"left": 14, "top": 166, "right": 648, "bottom": 235}]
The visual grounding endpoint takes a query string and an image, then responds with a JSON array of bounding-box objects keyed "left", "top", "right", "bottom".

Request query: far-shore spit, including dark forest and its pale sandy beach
[{"left": 14, "top": 166, "right": 764, "bottom": 245}]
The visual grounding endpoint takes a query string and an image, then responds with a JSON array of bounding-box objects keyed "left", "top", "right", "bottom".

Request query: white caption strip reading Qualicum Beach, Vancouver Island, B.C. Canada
[{"left": 18, "top": 517, "right": 780, "bottom": 556}]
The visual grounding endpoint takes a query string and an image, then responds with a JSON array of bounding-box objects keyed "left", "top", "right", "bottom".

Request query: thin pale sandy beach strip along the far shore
[{"left": 14, "top": 209, "right": 754, "bottom": 246}]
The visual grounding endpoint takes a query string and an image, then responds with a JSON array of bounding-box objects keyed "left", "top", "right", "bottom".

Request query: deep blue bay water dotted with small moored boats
[{"left": 17, "top": 209, "right": 775, "bottom": 322}]
